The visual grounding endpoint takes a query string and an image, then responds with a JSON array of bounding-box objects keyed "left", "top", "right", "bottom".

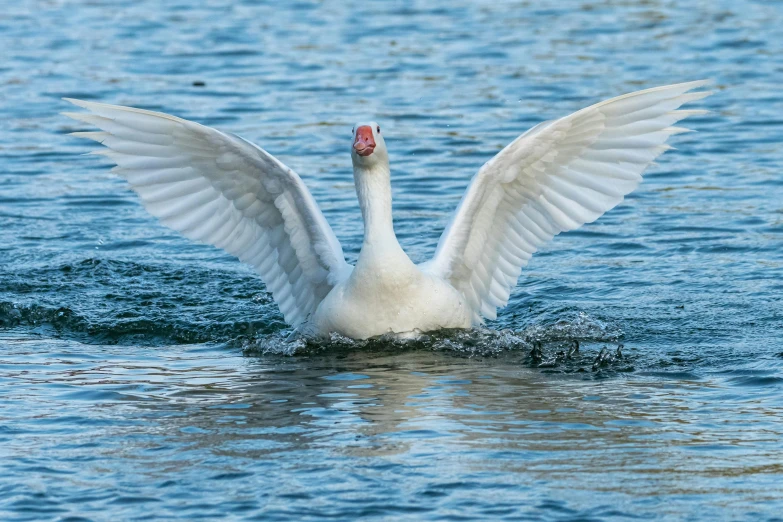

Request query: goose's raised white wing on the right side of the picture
[{"left": 423, "top": 81, "right": 710, "bottom": 324}]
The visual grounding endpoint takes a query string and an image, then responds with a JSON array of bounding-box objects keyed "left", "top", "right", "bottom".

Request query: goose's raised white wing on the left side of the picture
[{"left": 65, "top": 98, "right": 351, "bottom": 327}]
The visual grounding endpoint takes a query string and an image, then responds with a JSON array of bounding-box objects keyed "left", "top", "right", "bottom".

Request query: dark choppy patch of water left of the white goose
[{"left": 0, "top": 259, "right": 288, "bottom": 345}]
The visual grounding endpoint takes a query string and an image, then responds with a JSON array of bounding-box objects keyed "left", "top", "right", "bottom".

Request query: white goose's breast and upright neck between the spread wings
[{"left": 310, "top": 150, "right": 471, "bottom": 339}]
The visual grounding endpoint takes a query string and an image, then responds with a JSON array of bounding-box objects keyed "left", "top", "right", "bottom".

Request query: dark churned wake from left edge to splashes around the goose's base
[{"left": 0, "top": 258, "right": 627, "bottom": 372}]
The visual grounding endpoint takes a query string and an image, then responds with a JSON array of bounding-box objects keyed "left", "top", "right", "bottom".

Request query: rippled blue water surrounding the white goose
[{"left": 0, "top": 0, "right": 783, "bottom": 521}]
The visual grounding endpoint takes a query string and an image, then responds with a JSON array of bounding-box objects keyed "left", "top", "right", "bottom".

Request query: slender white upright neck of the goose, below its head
[{"left": 353, "top": 162, "right": 407, "bottom": 262}]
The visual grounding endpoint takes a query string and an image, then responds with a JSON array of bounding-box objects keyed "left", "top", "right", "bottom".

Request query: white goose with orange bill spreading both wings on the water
[{"left": 63, "top": 81, "right": 711, "bottom": 339}]
